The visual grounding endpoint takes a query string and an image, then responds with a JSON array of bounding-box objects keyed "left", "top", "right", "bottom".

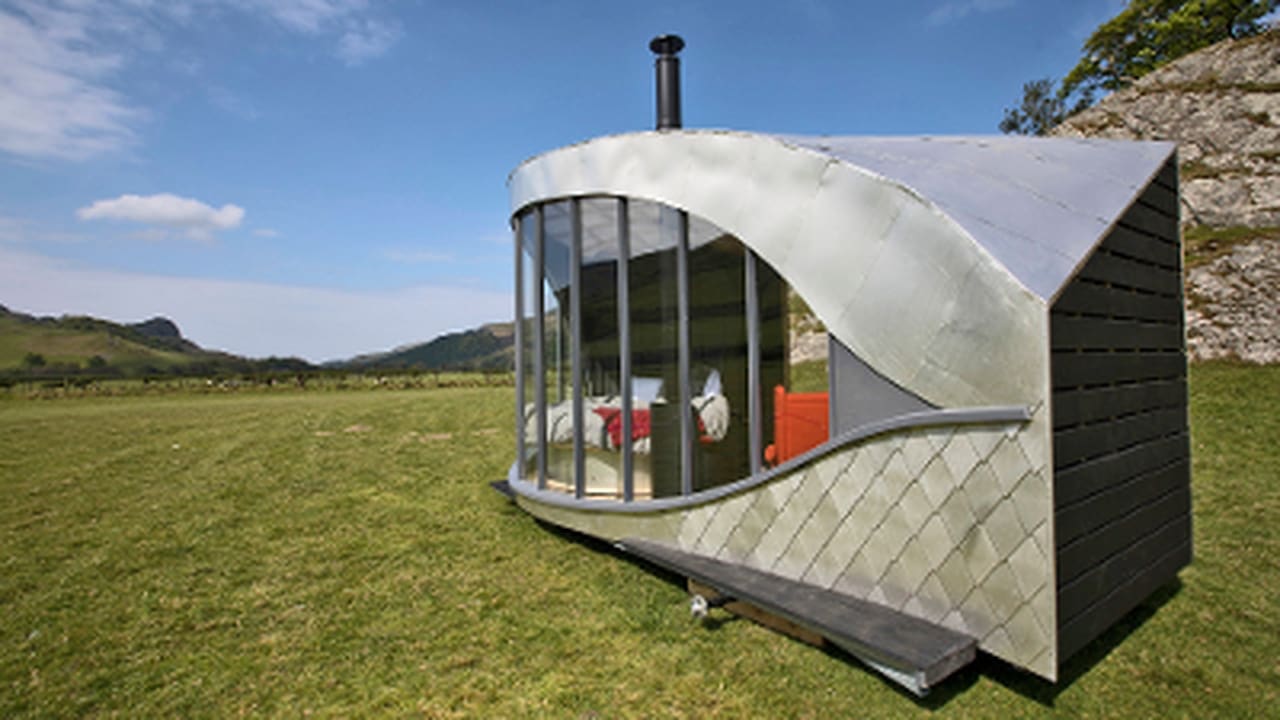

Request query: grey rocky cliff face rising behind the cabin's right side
[{"left": 1053, "top": 31, "right": 1280, "bottom": 363}]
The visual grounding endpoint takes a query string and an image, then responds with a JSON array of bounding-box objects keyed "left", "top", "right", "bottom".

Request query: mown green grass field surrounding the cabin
[{"left": 0, "top": 365, "right": 1280, "bottom": 717}]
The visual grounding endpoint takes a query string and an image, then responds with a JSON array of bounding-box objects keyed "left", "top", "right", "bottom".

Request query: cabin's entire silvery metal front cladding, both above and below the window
[{"left": 509, "top": 132, "right": 1080, "bottom": 679}]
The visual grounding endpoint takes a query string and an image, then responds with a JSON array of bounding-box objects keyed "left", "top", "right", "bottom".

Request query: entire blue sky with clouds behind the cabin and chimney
[{"left": 0, "top": 0, "right": 1124, "bottom": 361}]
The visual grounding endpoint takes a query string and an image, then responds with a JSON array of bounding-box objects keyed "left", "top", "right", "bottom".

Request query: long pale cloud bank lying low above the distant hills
[{"left": 0, "top": 246, "right": 512, "bottom": 363}]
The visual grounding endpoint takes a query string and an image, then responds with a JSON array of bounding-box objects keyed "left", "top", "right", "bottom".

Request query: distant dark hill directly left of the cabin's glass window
[{"left": 340, "top": 323, "right": 515, "bottom": 370}]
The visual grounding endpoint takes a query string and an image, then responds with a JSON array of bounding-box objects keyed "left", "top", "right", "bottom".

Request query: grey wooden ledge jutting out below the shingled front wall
[{"left": 617, "top": 538, "right": 977, "bottom": 696}]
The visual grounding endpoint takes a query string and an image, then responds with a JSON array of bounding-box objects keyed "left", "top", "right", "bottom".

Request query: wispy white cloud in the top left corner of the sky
[{"left": 0, "top": 0, "right": 402, "bottom": 160}]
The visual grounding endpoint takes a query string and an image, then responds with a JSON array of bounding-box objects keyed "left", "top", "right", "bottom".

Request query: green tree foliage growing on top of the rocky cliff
[{"left": 1000, "top": 0, "right": 1280, "bottom": 135}]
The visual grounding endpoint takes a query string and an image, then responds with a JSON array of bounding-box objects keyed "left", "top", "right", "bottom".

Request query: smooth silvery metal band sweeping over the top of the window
[{"left": 509, "top": 131, "right": 1047, "bottom": 407}]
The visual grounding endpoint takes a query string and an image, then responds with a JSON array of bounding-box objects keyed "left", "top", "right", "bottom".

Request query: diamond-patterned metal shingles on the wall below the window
[{"left": 681, "top": 407, "right": 1056, "bottom": 674}]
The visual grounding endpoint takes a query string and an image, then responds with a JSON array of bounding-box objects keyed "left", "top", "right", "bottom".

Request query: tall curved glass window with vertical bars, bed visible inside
[{"left": 516, "top": 196, "right": 827, "bottom": 501}]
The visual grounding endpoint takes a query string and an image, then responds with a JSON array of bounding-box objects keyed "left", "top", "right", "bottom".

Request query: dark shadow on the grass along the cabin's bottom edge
[{"left": 536, "top": 509, "right": 1183, "bottom": 711}]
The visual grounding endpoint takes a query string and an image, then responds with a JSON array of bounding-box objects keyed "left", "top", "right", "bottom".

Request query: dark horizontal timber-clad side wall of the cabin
[{"left": 1050, "top": 159, "right": 1192, "bottom": 662}]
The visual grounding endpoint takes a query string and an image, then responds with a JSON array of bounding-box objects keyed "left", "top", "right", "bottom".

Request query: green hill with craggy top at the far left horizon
[{"left": 0, "top": 305, "right": 315, "bottom": 378}]
